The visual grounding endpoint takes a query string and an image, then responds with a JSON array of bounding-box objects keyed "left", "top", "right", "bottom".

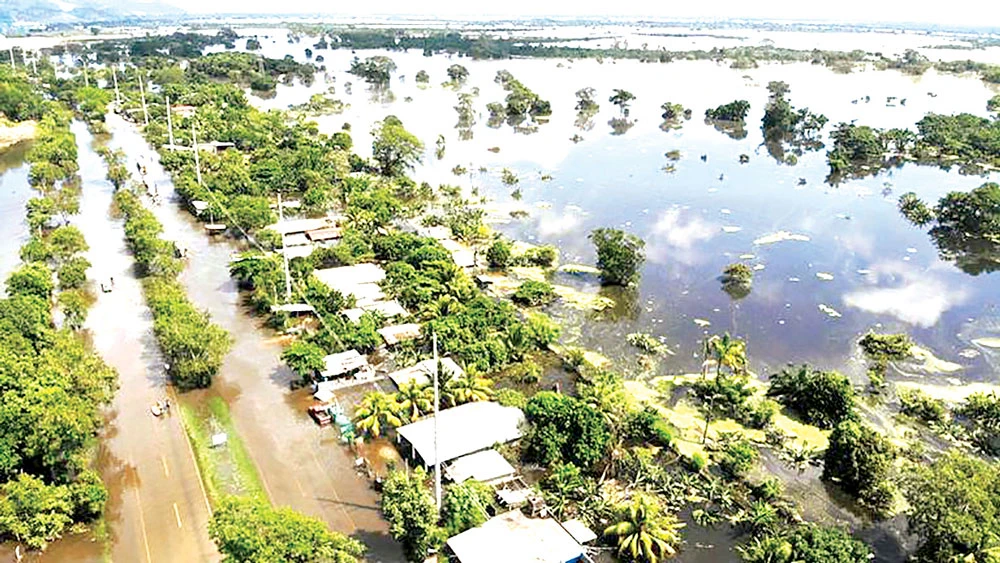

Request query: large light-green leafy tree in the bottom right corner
[{"left": 903, "top": 451, "right": 1000, "bottom": 563}]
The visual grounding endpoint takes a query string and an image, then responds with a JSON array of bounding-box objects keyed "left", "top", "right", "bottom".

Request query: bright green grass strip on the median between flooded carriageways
[{"left": 178, "top": 397, "right": 268, "bottom": 504}]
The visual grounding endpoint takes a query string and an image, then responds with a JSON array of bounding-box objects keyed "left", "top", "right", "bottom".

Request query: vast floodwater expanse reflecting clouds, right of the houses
[{"left": 229, "top": 30, "right": 1000, "bottom": 563}]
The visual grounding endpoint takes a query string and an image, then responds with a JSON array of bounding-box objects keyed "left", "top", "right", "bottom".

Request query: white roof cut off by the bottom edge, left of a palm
[{"left": 448, "top": 510, "right": 583, "bottom": 563}]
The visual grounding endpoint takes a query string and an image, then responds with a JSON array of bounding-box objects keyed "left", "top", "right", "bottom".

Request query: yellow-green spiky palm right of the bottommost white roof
[{"left": 604, "top": 496, "right": 684, "bottom": 563}]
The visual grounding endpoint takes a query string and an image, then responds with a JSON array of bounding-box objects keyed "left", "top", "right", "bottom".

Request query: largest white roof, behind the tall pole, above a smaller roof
[{"left": 396, "top": 401, "right": 524, "bottom": 468}]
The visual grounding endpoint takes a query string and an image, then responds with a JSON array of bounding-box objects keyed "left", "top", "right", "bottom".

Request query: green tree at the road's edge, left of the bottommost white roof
[{"left": 382, "top": 467, "right": 443, "bottom": 563}]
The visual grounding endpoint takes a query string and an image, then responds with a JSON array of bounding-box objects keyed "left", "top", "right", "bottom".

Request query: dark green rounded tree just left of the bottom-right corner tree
[{"left": 823, "top": 420, "right": 896, "bottom": 512}]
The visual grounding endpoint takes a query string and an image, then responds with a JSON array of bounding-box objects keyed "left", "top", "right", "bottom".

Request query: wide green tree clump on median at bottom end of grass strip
[{"left": 208, "top": 496, "right": 364, "bottom": 563}]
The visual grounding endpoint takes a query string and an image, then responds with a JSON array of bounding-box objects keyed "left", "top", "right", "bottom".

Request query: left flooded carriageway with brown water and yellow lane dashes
[{"left": 73, "top": 122, "right": 219, "bottom": 563}]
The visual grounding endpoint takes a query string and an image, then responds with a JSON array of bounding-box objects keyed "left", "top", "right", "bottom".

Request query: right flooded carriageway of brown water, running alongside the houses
[{"left": 108, "top": 115, "right": 403, "bottom": 562}]
